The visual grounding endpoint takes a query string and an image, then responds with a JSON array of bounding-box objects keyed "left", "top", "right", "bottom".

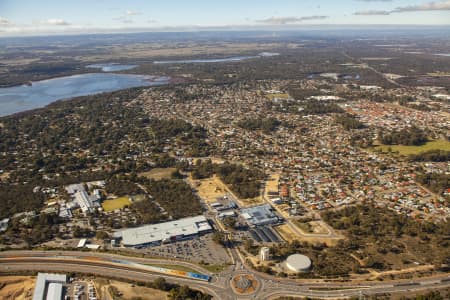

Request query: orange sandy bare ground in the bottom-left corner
[{"left": 0, "top": 276, "right": 36, "bottom": 300}]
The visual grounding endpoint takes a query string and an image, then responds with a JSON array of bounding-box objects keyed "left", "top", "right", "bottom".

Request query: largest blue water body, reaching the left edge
[{"left": 0, "top": 73, "right": 170, "bottom": 116}]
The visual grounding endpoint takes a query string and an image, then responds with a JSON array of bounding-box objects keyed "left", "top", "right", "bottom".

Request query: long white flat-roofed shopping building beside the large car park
[{"left": 114, "top": 216, "right": 212, "bottom": 247}]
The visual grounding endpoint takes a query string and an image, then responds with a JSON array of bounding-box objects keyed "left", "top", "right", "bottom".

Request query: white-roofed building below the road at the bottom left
[{"left": 33, "top": 273, "right": 67, "bottom": 300}]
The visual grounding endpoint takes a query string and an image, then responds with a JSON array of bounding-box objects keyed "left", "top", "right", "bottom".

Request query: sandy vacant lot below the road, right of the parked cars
[{"left": 95, "top": 279, "right": 167, "bottom": 300}]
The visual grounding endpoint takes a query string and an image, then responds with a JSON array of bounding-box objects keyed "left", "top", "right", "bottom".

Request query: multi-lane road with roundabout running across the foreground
[{"left": 0, "top": 251, "right": 450, "bottom": 300}]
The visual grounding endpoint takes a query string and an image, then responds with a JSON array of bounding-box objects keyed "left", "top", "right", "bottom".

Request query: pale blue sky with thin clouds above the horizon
[{"left": 0, "top": 0, "right": 450, "bottom": 36}]
